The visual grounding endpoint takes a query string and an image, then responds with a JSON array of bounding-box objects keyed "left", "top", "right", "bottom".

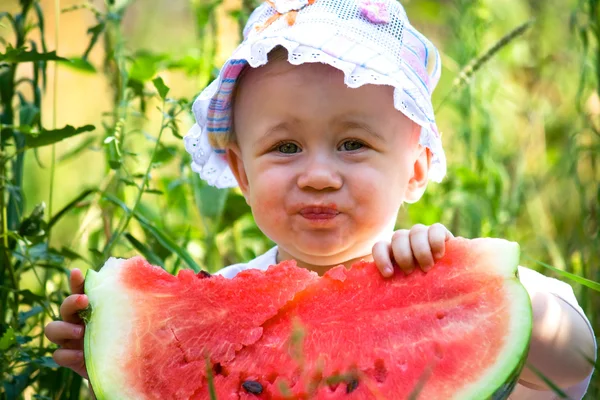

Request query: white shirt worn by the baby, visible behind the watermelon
[{"left": 217, "top": 246, "right": 595, "bottom": 400}]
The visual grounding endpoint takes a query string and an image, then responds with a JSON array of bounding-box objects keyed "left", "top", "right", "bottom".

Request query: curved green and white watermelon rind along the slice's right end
[{"left": 455, "top": 239, "right": 533, "bottom": 400}]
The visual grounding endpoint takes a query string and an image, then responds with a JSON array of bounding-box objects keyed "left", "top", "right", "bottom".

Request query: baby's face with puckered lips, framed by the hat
[{"left": 228, "top": 61, "right": 429, "bottom": 266}]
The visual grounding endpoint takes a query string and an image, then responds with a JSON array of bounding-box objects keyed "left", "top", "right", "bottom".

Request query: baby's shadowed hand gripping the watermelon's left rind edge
[{"left": 45, "top": 269, "right": 88, "bottom": 379}]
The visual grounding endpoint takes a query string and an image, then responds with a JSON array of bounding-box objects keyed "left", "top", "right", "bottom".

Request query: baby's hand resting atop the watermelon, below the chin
[{"left": 373, "top": 224, "right": 454, "bottom": 277}]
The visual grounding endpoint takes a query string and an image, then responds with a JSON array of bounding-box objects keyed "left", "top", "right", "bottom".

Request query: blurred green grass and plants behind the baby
[{"left": 0, "top": 0, "right": 600, "bottom": 399}]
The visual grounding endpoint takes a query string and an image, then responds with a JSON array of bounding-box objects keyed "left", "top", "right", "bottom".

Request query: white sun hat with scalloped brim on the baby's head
[{"left": 184, "top": 0, "right": 446, "bottom": 188}]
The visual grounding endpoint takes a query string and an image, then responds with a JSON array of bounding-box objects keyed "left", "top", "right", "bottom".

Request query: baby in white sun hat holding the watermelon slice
[{"left": 46, "top": 0, "right": 596, "bottom": 399}]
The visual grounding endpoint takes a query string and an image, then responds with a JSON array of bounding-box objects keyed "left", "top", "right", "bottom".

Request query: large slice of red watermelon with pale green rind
[{"left": 84, "top": 238, "right": 532, "bottom": 400}]
